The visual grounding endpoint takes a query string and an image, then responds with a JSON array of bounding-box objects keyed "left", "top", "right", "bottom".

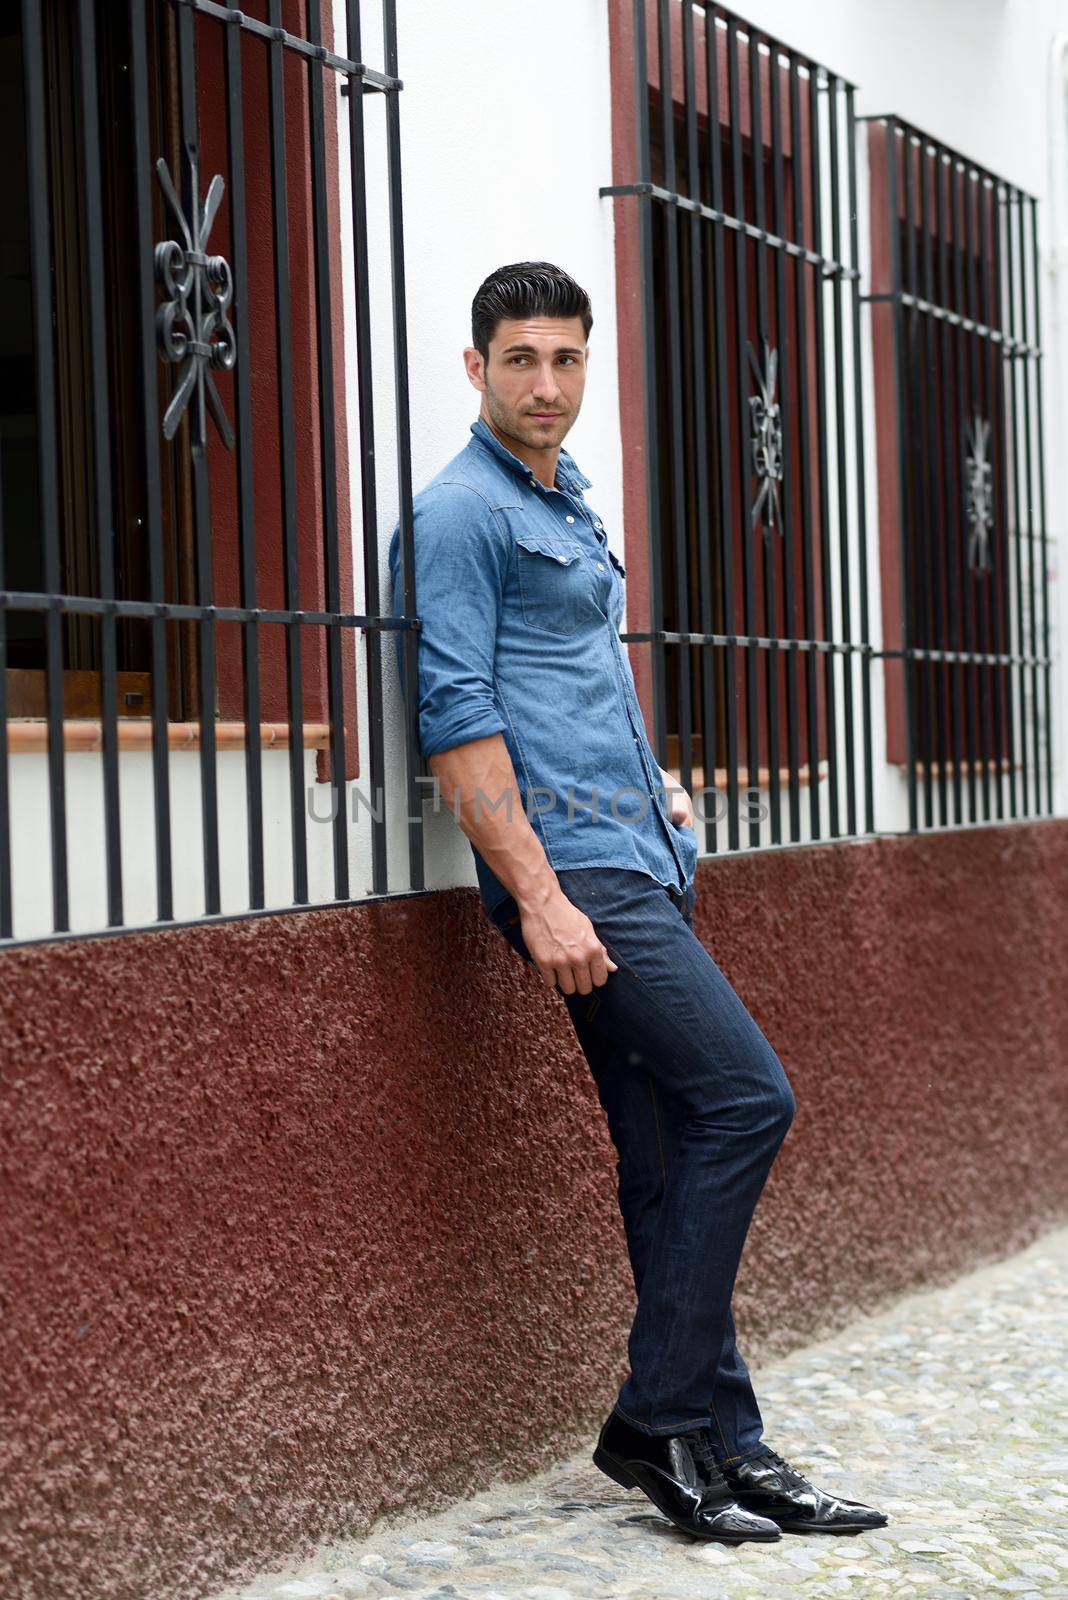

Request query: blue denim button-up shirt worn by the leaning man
[{"left": 389, "top": 418, "right": 697, "bottom": 912}]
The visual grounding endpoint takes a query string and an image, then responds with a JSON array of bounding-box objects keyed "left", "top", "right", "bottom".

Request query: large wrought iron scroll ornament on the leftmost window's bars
[{"left": 155, "top": 158, "right": 237, "bottom": 450}]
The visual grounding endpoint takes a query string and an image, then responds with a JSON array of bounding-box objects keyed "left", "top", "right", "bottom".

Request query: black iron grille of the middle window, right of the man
[{"left": 600, "top": 0, "right": 875, "bottom": 851}]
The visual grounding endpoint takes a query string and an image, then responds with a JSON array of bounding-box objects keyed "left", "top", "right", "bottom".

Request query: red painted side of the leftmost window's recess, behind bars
[{"left": 197, "top": 0, "right": 360, "bottom": 779}]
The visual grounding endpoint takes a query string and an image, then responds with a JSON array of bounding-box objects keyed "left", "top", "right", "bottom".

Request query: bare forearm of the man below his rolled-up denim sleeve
[{"left": 427, "top": 733, "right": 560, "bottom": 907}]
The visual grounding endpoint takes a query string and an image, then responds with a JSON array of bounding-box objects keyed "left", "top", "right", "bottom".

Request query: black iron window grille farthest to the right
[{"left": 862, "top": 117, "right": 1054, "bottom": 829}]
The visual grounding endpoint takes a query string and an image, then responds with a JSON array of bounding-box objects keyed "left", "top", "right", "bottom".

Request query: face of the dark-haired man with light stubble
[{"left": 464, "top": 317, "right": 588, "bottom": 450}]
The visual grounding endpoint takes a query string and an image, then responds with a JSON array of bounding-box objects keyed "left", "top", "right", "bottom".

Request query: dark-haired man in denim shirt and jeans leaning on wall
[{"left": 390, "top": 262, "right": 886, "bottom": 1544}]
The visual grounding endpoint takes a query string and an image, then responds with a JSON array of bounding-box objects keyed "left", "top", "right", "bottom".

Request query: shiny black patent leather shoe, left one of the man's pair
[{"left": 593, "top": 1411, "right": 782, "bottom": 1544}]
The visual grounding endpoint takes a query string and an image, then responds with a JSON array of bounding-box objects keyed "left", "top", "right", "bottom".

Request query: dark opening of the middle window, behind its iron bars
[{"left": 649, "top": 46, "right": 831, "bottom": 796}]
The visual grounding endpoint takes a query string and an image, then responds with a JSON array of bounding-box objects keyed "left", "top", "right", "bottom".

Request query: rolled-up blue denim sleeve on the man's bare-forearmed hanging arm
[{"left": 389, "top": 483, "right": 510, "bottom": 758}]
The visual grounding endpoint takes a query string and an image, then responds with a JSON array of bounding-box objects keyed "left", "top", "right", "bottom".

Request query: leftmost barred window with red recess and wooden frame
[{"left": 0, "top": 0, "right": 409, "bottom": 938}]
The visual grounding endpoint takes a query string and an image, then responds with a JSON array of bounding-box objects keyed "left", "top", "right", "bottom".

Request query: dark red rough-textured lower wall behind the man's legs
[{"left": 0, "top": 821, "right": 1068, "bottom": 1600}]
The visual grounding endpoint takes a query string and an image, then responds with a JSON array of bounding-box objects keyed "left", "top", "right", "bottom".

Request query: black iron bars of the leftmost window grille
[{"left": 0, "top": 0, "right": 424, "bottom": 941}]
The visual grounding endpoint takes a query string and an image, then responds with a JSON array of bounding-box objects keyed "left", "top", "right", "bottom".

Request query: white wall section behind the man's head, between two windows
[{"left": 353, "top": 0, "right": 624, "bottom": 886}]
